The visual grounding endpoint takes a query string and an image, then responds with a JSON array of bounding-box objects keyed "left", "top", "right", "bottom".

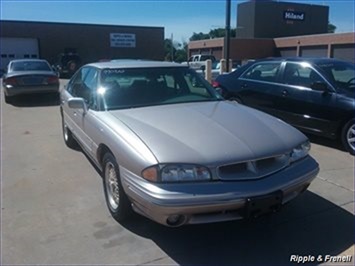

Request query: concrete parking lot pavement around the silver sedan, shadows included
[{"left": 1, "top": 81, "right": 354, "bottom": 265}]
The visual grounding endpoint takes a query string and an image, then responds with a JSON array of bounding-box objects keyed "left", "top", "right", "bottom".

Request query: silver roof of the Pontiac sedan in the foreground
[{"left": 86, "top": 59, "right": 187, "bottom": 69}]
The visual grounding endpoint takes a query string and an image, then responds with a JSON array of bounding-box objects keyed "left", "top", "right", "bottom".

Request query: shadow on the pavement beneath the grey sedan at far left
[{"left": 9, "top": 93, "right": 59, "bottom": 107}]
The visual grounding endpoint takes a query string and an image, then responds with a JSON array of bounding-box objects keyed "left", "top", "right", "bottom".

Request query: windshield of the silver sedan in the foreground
[{"left": 97, "top": 67, "right": 222, "bottom": 110}]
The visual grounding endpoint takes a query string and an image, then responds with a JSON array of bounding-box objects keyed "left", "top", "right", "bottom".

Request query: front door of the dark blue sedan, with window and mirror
[{"left": 278, "top": 62, "right": 338, "bottom": 133}]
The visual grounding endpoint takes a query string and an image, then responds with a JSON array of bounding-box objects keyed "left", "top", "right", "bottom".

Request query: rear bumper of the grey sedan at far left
[{"left": 3, "top": 83, "right": 59, "bottom": 96}]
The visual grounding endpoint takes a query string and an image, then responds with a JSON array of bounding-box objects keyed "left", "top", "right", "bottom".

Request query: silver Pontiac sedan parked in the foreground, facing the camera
[{"left": 60, "top": 60, "right": 319, "bottom": 226}]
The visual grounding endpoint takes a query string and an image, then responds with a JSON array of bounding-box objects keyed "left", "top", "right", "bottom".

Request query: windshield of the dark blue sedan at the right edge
[{"left": 318, "top": 62, "right": 355, "bottom": 91}]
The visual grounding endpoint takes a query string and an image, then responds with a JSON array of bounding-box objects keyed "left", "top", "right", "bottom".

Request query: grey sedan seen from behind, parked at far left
[{"left": 2, "top": 59, "right": 59, "bottom": 103}]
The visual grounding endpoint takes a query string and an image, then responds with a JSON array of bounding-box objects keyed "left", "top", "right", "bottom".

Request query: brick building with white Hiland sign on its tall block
[{"left": 188, "top": 1, "right": 355, "bottom": 63}]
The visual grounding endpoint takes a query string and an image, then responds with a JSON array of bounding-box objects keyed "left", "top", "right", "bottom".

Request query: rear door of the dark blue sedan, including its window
[{"left": 238, "top": 61, "right": 282, "bottom": 116}]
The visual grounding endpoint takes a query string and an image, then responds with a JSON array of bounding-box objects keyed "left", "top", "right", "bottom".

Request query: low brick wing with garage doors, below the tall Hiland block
[{"left": 188, "top": 32, "right": 355, "bottom": 62}]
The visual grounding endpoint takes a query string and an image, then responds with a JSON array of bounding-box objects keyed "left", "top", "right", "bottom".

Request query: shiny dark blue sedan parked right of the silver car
[{"left": 214, "top": 58, "right": 355, "bottom": 154}]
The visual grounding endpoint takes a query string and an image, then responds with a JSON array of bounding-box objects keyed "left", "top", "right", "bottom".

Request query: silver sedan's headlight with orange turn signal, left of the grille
[{"left": 142, "top": 164, "right": 211, "bottom": 182}]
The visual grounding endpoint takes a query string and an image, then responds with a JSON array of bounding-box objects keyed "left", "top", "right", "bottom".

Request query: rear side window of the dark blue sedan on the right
[{"left": 241, "top": 62, "right": 280, "bottom": 82}]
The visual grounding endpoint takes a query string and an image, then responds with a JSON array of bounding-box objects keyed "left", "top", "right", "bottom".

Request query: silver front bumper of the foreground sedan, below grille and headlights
[{"left": 120, "top": 156, "right": 319, "bottom": 226}]
